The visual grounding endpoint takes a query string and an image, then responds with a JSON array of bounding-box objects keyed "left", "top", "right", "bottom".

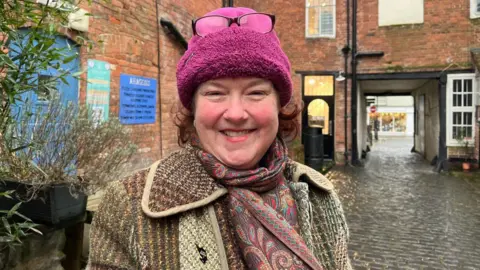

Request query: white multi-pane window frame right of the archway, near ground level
[{"left": 447, "top": 73, "right": 478, "bottom": 146}]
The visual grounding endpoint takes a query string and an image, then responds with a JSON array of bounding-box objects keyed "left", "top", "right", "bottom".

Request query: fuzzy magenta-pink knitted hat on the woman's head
[{"left": 177, "top": 8, "right": 292, "bottom": 109}]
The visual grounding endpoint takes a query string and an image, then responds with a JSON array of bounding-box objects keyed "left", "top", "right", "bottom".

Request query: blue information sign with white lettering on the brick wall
[{"left": 120, "top": 74, "right": 157, "bottom": 124}]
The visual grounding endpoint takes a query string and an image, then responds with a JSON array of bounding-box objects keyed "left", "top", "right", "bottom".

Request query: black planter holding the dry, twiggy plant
[{"left": 0, "top": 181, "right": 87, "bottom": 228}]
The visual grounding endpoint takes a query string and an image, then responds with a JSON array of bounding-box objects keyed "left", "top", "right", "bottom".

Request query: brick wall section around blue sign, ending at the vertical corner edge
[{"left": 80, "top": 0, "right": 161, "bottom": 167}]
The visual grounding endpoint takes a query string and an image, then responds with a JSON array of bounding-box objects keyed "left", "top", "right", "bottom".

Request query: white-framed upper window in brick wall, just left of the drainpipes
[{"left": 305, "top": 0, "right": 335, "bottom": 38}]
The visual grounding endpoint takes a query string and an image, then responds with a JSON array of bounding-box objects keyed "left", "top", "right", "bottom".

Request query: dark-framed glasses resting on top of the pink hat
[{"left": 192, "top": 13, "right": 275, "bottom": 37}]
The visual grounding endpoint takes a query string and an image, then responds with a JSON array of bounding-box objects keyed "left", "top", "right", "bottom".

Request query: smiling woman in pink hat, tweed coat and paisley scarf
[{"left": 89, "top": 8, "right": 351, "bottom": 270}]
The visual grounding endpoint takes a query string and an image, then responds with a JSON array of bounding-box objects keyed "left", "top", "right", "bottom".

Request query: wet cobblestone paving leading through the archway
[{"left": 329, "top": 138, "right": 480, "bottom": 269}]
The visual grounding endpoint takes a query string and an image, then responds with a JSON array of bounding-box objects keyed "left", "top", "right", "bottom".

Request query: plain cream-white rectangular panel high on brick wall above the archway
[{"left": 378, "top": 0, "right": 424, "bottom": 26}]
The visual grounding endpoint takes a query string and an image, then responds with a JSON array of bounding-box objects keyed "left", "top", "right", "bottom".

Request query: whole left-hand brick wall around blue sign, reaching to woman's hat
[{"left": 80, "top": 0, "right": 222, "bottom": 168}]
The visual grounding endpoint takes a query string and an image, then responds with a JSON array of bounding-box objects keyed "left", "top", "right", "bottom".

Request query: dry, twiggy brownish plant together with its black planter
[{"left": 0, "top": 96, "right": 136, "bottom": 227}]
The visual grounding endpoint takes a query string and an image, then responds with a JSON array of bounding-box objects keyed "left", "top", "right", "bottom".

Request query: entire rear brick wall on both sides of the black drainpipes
[{"left": 234, "top": 0, "right": 480, "bottom": 161}]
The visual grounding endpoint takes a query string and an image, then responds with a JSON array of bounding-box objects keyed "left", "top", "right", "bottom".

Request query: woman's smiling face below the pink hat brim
[{"left": 194, "top": 78, "right": 280, "bottom": 169}]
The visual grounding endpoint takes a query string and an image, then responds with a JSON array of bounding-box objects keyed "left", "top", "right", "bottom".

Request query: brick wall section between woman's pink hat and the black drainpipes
[{"left": 234, "top": 0, "right": 351, "bottom": 163}]
